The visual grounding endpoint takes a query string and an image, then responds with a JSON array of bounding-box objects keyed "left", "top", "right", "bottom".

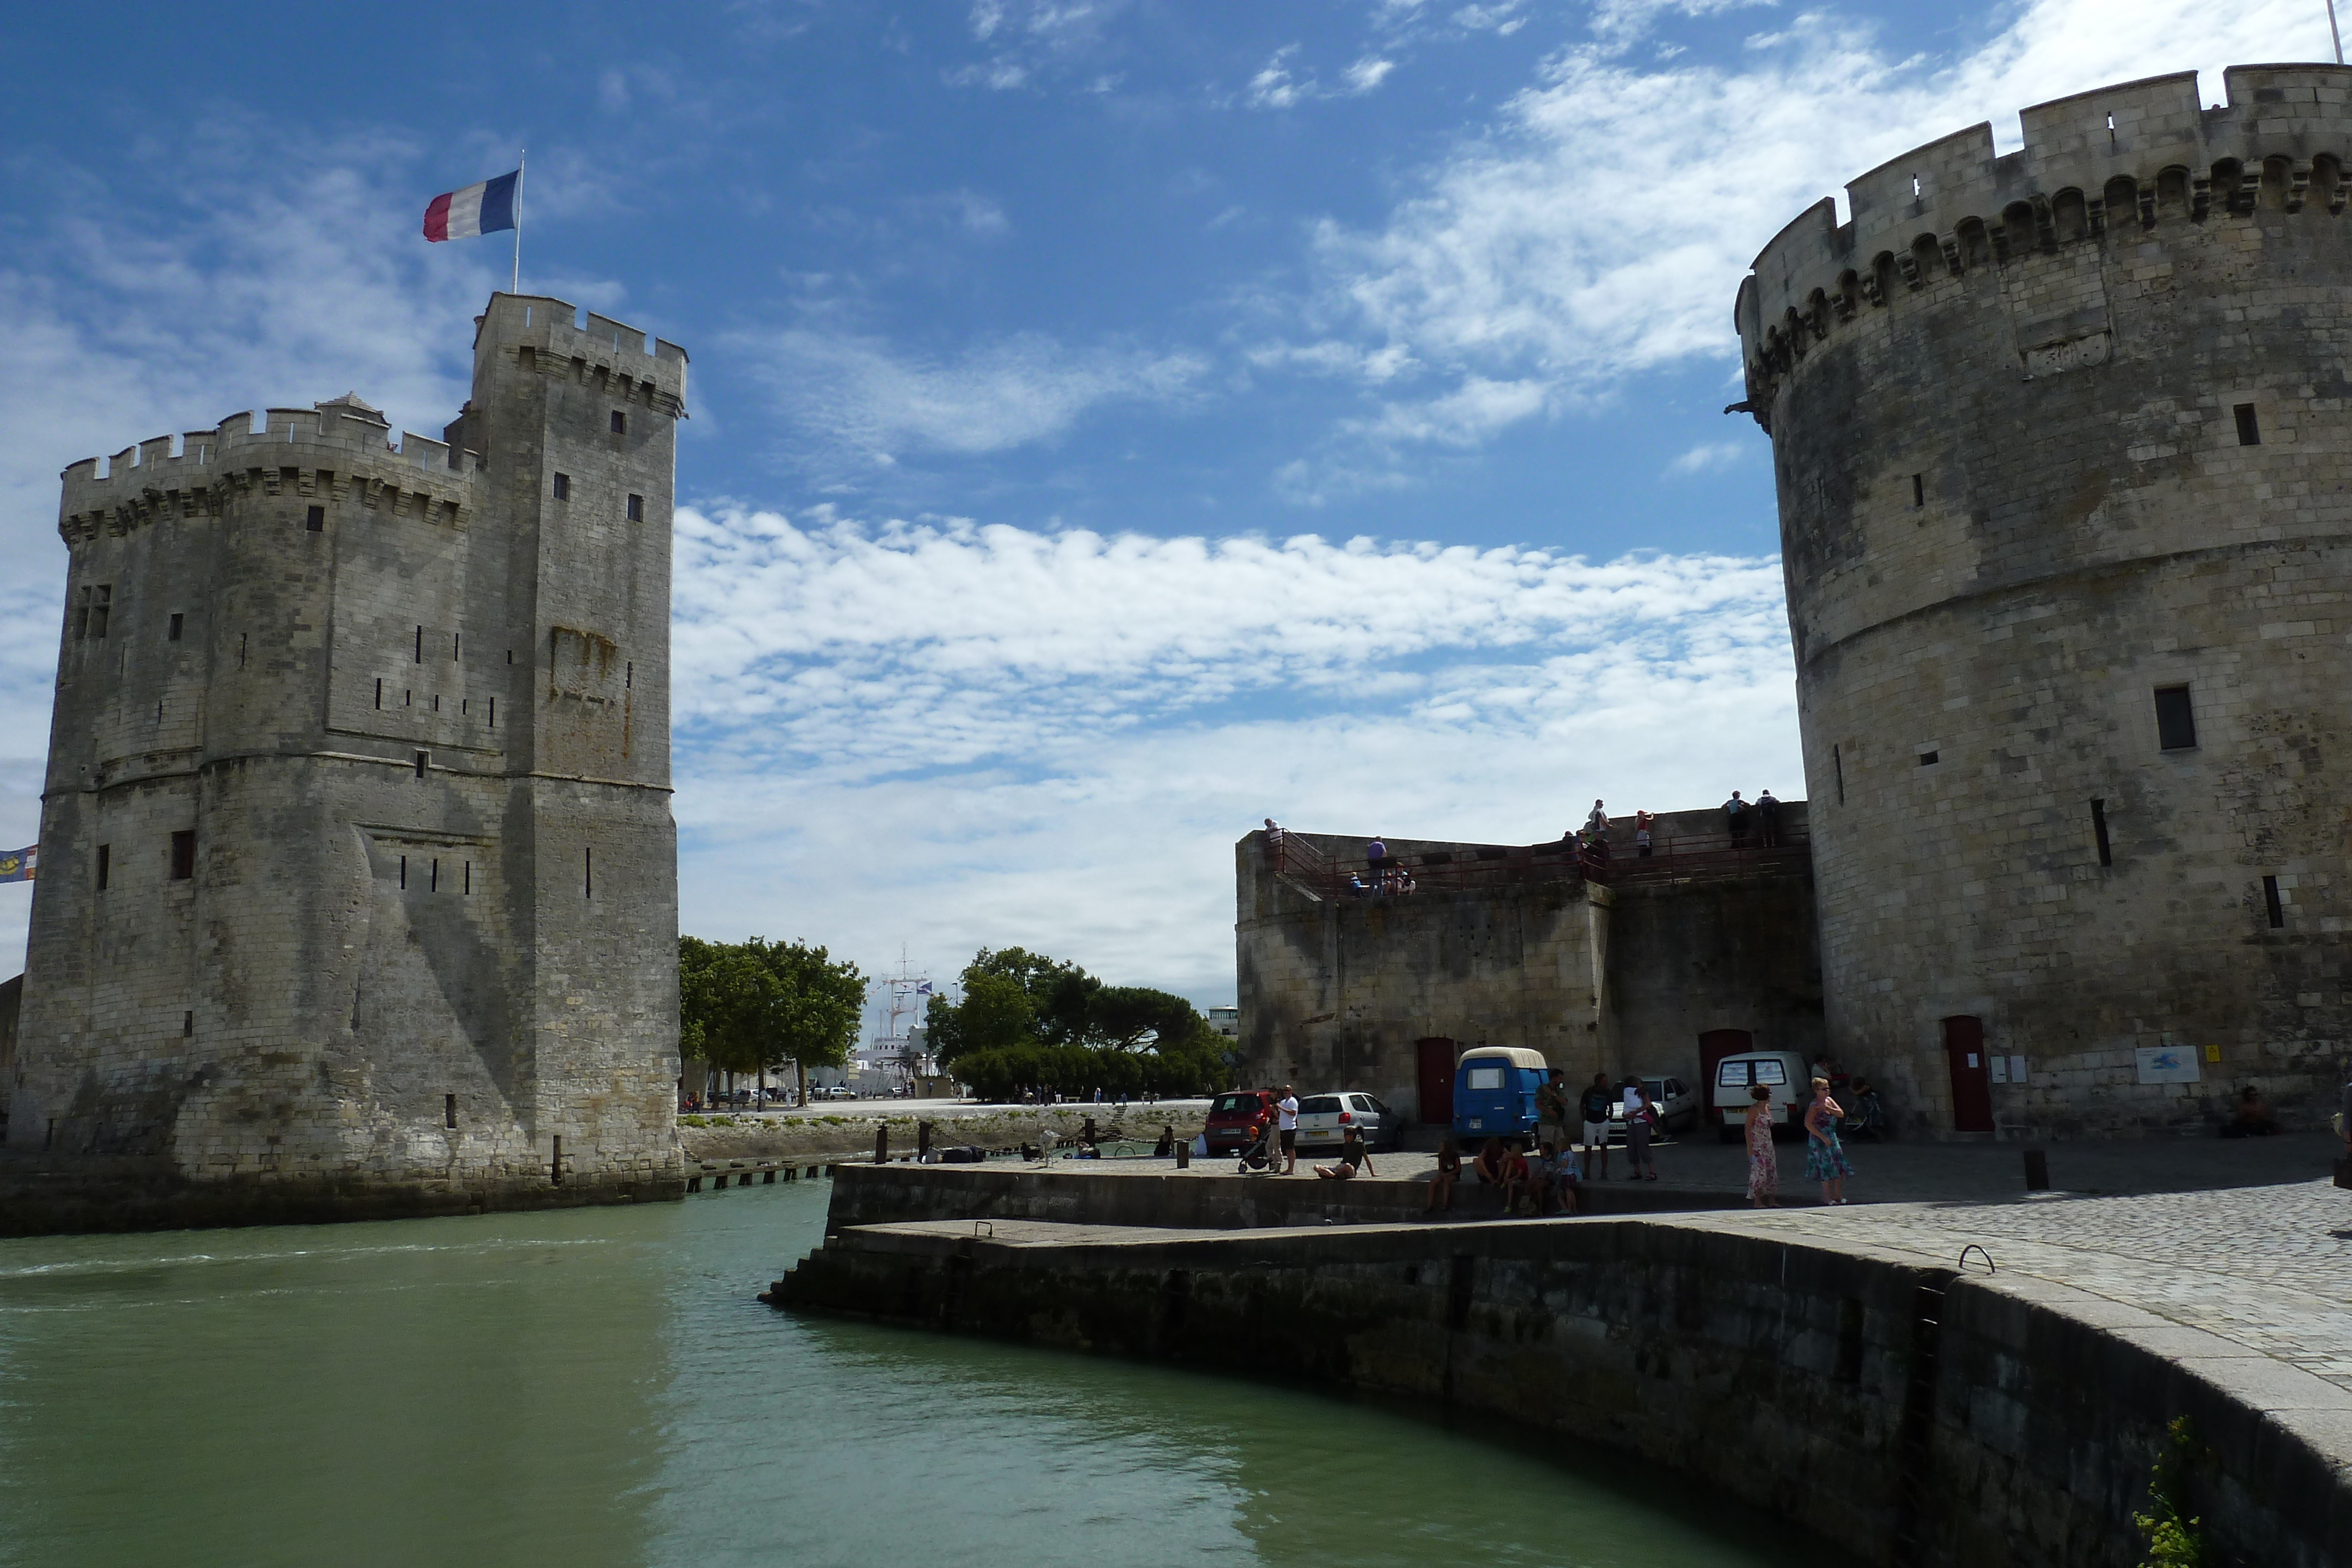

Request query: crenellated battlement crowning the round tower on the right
[{"left": 1733, "top": 66, "right": 2352, "bottom": 428}]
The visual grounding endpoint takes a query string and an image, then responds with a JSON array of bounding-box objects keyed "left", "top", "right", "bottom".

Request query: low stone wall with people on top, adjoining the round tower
[{"left": 1235, "top": 801, "right": 1825, "bottom": 1119}]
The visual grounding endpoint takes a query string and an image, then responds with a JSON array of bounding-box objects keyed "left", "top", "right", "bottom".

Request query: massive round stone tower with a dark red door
[{"left": 1738, "top": 66, "right": 2352, "bottom": 1133}]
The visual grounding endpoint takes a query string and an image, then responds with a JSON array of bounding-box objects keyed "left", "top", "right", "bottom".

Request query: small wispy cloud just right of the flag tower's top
[{"left": 736, "top": 329, "right": 1207, "bottom": 461}]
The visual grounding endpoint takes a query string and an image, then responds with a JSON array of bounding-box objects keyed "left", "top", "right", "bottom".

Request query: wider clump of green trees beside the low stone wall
[{"left": 924, "top": 947, "right": 1228, "bottom": 1100}]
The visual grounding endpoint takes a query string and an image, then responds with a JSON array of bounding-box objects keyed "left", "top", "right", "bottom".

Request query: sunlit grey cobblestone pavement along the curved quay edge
[{"left": 1719, "top": 1182, "right": 2352, "bottom": 1389}]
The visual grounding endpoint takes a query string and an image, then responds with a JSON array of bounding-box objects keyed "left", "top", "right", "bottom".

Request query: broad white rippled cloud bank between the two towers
[{"left": 675, "top": 508, "right": 1797, "bottom": 999}]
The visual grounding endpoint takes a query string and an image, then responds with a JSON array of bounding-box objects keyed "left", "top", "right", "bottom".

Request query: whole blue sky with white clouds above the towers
[{"left": 0, "top": 0, "right": 2328, "bottom": 1020}]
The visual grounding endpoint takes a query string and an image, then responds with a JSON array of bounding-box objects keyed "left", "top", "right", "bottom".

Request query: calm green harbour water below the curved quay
[{"left": 0, "top": 1182, "right": 1797, "bottom": 1568}]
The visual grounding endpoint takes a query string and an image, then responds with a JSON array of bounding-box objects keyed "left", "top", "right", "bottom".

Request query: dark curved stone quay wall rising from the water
[{"left": 764, "top": 1213, "right": 2352, "bottom": 1568}]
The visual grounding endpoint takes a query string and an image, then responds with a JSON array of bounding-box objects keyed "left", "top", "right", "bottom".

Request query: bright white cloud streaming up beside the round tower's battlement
[{"left": 1315, "top": 0, "right": 2328, "bottom": 482}]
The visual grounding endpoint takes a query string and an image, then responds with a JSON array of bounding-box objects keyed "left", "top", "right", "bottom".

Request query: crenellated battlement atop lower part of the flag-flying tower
[{"left": 56, "top": 393, "right": 482, "bottom": 543}]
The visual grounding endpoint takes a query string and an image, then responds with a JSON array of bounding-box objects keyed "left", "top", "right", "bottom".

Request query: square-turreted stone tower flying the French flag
[{"left": 7, "top": 294, "right": 687, "bottom": 1215}]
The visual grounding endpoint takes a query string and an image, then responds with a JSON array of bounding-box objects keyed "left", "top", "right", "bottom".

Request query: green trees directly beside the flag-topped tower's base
[{"left": 677, "top": 935, "right": 866, "bottom": 1072}]
